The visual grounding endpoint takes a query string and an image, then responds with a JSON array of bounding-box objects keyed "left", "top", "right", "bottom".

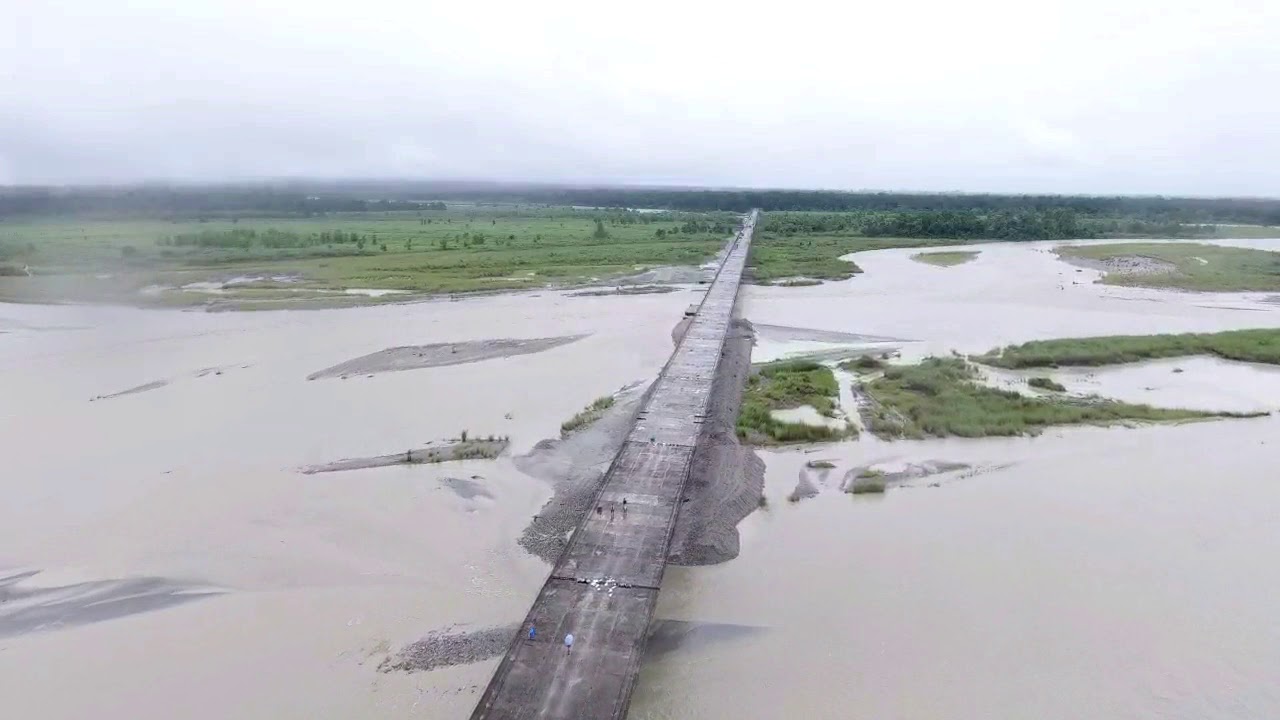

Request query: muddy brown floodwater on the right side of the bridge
[{"left": 630, "top": 243, "right": 1280, "bottom": 720}]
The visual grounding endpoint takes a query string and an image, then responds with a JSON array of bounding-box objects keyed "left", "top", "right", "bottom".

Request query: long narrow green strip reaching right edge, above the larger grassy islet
[{"left": 974, "top": 328, "right": 1280, "bottom": 369}]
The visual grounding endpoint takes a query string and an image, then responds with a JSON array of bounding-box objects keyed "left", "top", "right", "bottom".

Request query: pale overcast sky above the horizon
[{"left": 0, "top": 0, "right": 1280, "bottom": 196}]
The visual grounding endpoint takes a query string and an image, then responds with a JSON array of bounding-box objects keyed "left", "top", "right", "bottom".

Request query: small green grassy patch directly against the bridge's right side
[{"left": 737, "top": 360, "right": 847, "bottom": 443}]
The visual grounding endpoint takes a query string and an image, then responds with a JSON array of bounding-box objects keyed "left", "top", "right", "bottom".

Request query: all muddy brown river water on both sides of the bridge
[{"left": 0, "top": 241, "right": 1280, "bottom": 720}]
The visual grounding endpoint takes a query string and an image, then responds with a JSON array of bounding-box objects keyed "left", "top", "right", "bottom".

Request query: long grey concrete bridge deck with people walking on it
[{"left": 471, "top": 211, "right": 759, "bottom": 720}]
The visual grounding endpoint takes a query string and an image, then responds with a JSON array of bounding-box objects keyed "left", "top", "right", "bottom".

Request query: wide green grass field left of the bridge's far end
[{"left": 0, "top": 208, "right": 737, "bottom": 305}]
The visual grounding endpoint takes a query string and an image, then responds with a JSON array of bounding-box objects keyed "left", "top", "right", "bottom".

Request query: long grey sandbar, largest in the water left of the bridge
[{"left": 307, "top": 334, "right": 586, "bottom": 380}]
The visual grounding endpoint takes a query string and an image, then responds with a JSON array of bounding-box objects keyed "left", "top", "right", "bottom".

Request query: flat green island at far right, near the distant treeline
[{"left": 1057, "top": 242, "right": 1280, "bottom": 292}]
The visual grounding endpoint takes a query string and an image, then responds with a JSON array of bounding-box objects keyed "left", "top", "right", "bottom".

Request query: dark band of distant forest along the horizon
[{"left": 0, "top": 182, "right": 1280, "bottom": 224}]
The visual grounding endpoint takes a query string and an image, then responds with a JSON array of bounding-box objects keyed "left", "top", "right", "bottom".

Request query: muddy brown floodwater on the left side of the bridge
[{"left": 0, "top": 292, "right": 689, "bottom": 720}]
